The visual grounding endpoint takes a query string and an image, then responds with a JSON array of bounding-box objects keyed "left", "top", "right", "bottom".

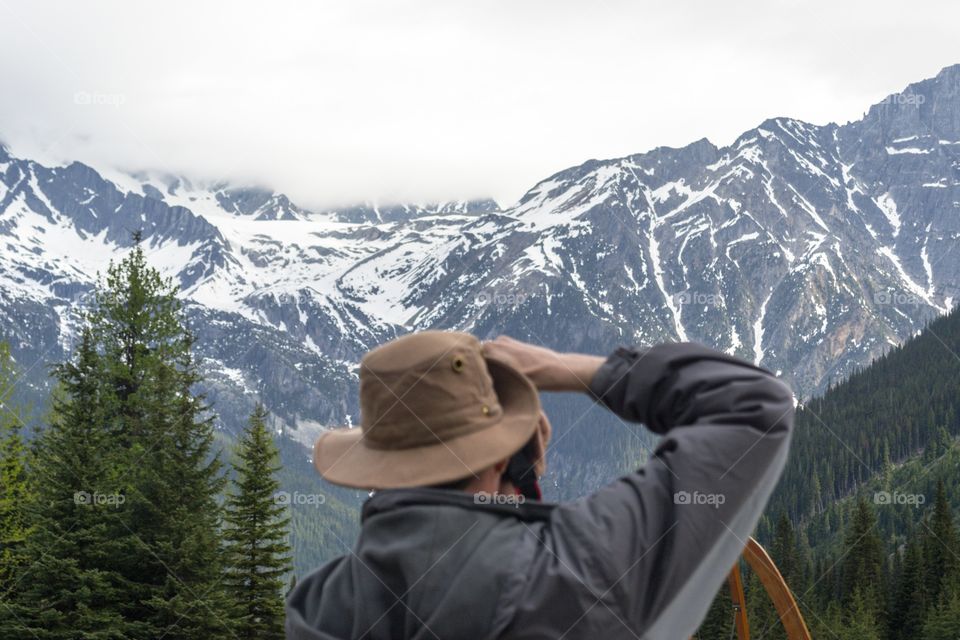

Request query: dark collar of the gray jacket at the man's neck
[{"left": 360, "top": 488, "right": 557, "bottom": 522}]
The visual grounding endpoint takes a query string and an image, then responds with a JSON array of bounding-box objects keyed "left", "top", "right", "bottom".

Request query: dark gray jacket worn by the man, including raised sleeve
[{"left": 287, "top": 343, "right": 793, "bottom": 640}]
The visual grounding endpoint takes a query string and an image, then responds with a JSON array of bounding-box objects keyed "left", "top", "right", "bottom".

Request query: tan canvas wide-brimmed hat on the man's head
[{"left": 313, "top": 331, "right": 549, "bottom": 489}]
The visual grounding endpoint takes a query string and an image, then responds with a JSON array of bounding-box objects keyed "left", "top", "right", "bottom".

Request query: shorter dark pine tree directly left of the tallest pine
[{"left": 7, "top": 330, "right": 140, "bottom": 640}]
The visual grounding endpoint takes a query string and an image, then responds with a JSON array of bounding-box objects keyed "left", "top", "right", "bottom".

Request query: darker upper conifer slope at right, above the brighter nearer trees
[{"left": 760, "top": 307, "right": 960, "bottom": 532}]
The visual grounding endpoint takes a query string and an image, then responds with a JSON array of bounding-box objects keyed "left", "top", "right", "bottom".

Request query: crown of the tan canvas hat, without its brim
[{"left": 360, "top": 331, "right": 503, "bottom": 449}]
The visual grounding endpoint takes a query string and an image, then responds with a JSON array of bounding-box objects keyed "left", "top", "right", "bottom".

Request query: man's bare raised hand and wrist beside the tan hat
[{"left": 483, "top": 336, "right": 604, "bottom": 391}]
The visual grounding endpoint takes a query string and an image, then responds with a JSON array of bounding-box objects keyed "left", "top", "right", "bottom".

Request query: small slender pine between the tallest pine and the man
[{"left": 226, "top": 405, "right": 291, "bottom": 640}]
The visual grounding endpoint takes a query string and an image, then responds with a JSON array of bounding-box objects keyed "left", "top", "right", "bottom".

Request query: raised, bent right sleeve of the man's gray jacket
[{"left": 516, "top": 343, "right": 794, "bottom": 640}]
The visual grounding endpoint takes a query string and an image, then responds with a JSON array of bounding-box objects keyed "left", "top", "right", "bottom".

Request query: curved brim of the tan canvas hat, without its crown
[{"left": 313, "top": 354, "right": 540, "bottom": 489}]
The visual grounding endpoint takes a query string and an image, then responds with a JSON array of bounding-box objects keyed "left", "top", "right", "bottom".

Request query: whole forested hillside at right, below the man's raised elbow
[{"left": 699, "top": 302, "right": 960, "bottom": 640}]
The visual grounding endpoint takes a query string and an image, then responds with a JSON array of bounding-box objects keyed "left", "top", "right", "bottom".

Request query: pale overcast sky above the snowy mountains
[{"left": 0, "top": 0, "right": 960, "bottom": 207}]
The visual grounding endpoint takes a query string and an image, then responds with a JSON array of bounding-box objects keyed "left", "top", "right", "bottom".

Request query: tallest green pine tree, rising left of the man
[{"left": 90, "top": 244, "right": 229, "bottom": 640}]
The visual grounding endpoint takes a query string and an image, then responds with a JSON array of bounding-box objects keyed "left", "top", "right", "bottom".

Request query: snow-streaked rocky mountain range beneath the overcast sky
[{"left": 0, "top": 65, "right": 960, "bottom": 464}]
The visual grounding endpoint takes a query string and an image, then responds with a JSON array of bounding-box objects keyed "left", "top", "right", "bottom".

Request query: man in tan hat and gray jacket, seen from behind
[{"left": 287, "top": 332, "right": 793, "bottom": 640}]
